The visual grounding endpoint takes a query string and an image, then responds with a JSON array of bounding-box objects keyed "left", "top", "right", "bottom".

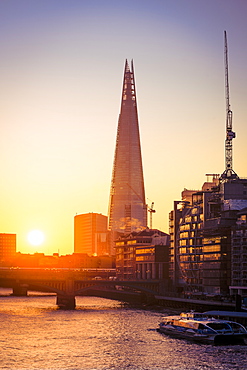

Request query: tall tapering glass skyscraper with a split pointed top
[{"left": 109, "top": 60, "right": 147, "bottom": 233}]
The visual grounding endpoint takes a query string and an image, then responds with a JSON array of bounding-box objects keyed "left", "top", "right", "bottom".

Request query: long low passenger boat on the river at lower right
[{"left": 158, "top": 312, "right": 247, "bottom": 344}]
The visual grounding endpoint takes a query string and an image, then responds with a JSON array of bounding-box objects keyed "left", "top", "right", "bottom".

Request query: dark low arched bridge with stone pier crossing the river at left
[{"left": 0, "top": 268, "right": 163, "bottom": 309}]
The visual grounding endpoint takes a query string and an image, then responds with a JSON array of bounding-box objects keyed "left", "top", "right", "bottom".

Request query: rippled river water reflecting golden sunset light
[{"left": 0, "top": 290, "right": 247, "bottom": 370}]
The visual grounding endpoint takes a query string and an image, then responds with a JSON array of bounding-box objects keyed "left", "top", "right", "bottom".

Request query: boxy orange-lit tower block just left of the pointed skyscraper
[{"left": 74, "top": 213, "right": 109, "bottom": 256}]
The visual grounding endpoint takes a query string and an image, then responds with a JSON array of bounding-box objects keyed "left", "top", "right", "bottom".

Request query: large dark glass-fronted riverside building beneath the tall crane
[{"left": 170, "top": 175, "right": 247, "bottom": 295}]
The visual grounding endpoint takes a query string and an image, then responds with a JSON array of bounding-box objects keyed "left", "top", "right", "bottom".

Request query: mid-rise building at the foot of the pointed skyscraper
[{"left": 115, "top": 228, "right": 170, "bottom": 280}]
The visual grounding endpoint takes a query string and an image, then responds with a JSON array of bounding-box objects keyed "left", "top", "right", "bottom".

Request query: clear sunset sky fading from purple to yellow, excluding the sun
[{"left": 0, "top": 0, "right": 247, "bottom": 254}]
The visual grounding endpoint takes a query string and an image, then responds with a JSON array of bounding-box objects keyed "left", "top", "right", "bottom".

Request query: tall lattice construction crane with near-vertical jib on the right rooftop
[{"left": 221, "top": 31, "right": 238, "bottom": 179}]
